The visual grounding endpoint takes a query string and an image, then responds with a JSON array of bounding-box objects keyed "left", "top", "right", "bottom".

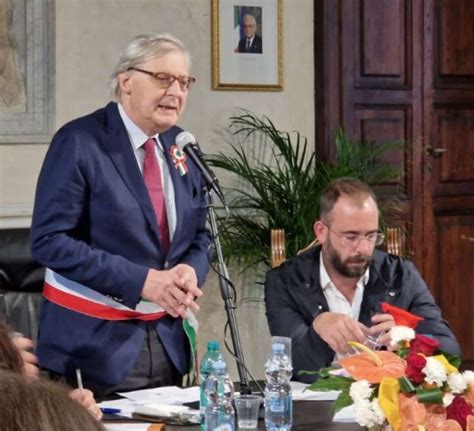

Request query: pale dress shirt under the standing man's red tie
[{"left": 118, "top": 103, "right": 176, "bottom": 242}]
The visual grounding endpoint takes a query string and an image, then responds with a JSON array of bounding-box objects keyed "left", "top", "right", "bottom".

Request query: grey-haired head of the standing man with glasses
[{"left": 111, "top": 33, "right": 194, "bottom": 136}]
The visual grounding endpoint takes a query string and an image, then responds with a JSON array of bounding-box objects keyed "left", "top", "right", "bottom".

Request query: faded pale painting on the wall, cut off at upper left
[{"left": 0, "top": 0, "right": 54, "bottom": 144}]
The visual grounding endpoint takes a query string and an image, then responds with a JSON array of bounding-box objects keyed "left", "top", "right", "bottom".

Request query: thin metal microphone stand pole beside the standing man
[{"left": 206, "top": 189, "right": 252, "bottom": 394}]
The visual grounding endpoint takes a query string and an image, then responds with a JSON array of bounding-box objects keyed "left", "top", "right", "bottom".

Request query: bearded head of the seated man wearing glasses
[{"left": 314, "top": 177, "right": 383, "bottom": 278}]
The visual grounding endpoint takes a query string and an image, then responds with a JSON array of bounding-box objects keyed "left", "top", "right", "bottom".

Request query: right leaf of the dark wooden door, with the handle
[{"left": 422, "top": 0, "right": 474, "bottom": 367}]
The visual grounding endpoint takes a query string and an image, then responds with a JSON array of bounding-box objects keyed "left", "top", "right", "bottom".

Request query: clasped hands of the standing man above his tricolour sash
[{"left": 142, "top": 263, "right": 202, "bottom": 318}]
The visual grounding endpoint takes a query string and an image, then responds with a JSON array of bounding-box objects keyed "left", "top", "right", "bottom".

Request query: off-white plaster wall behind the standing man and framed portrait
[{"left": 0, "top": 0, "right": 314, "bottom": 377}]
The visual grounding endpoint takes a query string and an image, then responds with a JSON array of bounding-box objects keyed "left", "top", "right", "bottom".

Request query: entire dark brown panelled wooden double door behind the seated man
[{"left": 315, "top": 0, "right": 474, "bottom": 361}]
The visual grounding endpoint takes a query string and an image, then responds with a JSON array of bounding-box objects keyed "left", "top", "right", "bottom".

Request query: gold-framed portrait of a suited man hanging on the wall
[{"left": 211, "top": 0, "right": 283, "bottom": 91}]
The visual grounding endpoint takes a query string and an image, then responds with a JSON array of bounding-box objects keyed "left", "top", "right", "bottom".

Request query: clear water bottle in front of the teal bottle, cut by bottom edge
[{"left": 205, "top": 361, "right": 235, "bottom": 431}]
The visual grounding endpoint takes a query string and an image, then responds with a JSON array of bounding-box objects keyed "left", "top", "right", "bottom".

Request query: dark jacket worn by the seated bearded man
[{"left": 265, "top": 247, "right": 461, "bottom": 382}]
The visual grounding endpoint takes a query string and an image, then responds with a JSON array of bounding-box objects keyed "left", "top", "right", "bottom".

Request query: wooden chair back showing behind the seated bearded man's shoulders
[{"left": 270, "top": 226, "right": 405, "bottom": 268}]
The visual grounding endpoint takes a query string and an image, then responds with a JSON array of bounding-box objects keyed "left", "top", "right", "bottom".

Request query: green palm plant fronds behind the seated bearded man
[{"left": 207, "top": 110, "right": 400, "bottom": 276}]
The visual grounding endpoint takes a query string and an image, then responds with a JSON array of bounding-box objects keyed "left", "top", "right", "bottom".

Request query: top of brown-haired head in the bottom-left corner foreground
[{"left": 0, "top": 371, "right": 104, "bottom": 431}]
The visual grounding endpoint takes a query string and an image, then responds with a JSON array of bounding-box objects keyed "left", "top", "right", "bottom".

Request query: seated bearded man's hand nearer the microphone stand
[{"left": 313, "top": 312, "right": 369, "bottom": 353}]
